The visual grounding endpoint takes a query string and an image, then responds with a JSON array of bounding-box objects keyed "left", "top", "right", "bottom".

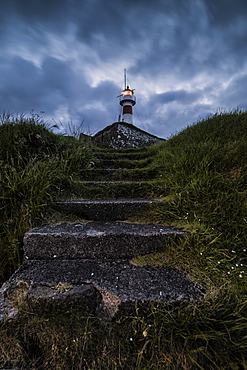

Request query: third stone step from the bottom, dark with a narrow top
[{"left": 52, "top": 199, "right": 164, "bottom": 221}]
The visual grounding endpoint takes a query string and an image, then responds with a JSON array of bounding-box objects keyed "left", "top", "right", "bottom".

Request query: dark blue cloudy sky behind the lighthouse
[{"left": 0, "top": 0, "right": 247, "bottom": 137}]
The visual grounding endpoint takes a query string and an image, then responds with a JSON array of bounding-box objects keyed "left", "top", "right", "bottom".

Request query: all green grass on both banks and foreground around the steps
[{"left": 0, "top": 112, "right": 247, "bottom": 370}]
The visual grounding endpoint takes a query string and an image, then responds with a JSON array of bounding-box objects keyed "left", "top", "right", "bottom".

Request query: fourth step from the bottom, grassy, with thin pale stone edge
[{"left": 63, "top": 180, "right": 168, "bottom": 200}]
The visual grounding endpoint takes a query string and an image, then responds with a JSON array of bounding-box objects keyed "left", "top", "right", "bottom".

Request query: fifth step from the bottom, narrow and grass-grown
[{"left": 81, "top": 168, "right": 158, "bottom": 181}]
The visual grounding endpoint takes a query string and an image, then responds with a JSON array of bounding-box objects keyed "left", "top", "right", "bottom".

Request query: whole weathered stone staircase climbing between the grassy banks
[{"left": 0, "top": 148, "right": 202, "bottom": 319}]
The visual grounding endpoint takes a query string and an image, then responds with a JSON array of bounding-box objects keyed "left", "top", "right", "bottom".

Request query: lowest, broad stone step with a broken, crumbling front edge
[{"left": 0, "top": 260, "right": 203, "bottom": 318}]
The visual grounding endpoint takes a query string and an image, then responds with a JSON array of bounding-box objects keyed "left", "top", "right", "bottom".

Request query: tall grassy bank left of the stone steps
[{"left": 0, "top": 115, "right": 90, "bottom": 283}]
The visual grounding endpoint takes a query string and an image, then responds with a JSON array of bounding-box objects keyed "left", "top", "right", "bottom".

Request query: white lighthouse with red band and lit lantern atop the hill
[{"left": 119, "top": 69, "right": 136, "bottom": 124}]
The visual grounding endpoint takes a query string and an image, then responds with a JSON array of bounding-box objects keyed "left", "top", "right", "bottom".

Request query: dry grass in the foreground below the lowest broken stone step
[{"left": 0, "top": 294, "right": 247, "bottom": 369}]
